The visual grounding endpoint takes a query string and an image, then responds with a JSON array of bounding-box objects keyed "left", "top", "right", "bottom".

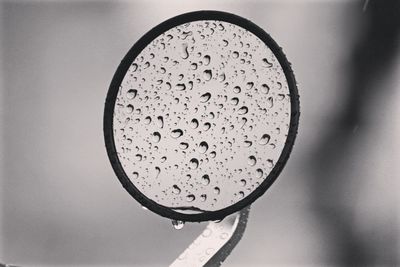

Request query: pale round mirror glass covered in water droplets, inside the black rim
[{"left": 113, "top": 20, "right": 291, "bottom": 213}]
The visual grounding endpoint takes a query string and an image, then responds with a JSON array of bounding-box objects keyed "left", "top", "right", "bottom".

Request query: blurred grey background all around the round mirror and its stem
[{"left": 0, "top": 0, "right": 400, "bottom": 267}]
